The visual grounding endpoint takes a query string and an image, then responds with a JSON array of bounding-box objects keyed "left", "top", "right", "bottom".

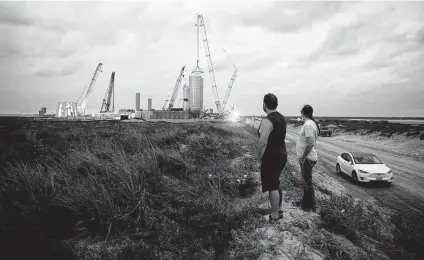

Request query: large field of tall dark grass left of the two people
[{"left": 0, "top": 122, "right": 254, "bottom": 259}]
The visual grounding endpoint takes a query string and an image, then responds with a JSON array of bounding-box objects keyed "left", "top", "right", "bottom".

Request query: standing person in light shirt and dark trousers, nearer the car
[{"left": 295, "top": 105, "right": 320, "bottom": 211}]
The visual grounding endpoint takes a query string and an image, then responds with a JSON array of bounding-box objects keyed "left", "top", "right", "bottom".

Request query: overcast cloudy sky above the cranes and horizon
[{"left": 0, "top": 0, "right": 424, "bottom": 116}]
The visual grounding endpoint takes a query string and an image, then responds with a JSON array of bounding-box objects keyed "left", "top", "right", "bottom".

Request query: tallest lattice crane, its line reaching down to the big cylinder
[{"left": 197, "top": 14, "right": 221, "bottom": 113}]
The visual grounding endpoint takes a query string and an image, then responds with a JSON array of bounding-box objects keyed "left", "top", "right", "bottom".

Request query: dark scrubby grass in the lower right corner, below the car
[{"left": 318, "top": 192, "right": 424, "bottom": 260}]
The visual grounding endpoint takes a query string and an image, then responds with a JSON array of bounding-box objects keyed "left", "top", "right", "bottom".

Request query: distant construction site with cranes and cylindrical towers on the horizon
[{"left": 55, "top": 14, "right": 237, "bottom": 121}]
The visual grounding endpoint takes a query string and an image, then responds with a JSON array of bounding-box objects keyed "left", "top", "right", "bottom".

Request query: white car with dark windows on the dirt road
[{"left": 336, "top": 152, "right": 393, "bottom": 184}]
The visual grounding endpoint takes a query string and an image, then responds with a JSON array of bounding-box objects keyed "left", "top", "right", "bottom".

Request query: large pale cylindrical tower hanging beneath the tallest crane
[{"left": 188, "top": 66, "right": 203, "bottom": 112}]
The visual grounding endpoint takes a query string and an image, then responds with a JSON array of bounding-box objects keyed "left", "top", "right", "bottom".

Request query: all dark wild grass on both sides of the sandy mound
[{"left": 0, "top": 118, "right": 424, "bottom": 260}]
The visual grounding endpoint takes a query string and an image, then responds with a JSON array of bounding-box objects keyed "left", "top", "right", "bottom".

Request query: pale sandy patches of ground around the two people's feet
[{"left": 232, "top": 148, "right": 387, "bottom": 260}]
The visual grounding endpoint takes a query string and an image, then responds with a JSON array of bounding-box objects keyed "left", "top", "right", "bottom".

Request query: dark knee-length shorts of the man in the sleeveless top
[{"left": 261, "top": 154, "right": 287, "bottom": 192}]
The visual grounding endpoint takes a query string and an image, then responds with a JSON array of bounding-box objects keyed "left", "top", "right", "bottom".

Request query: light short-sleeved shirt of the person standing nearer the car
[{"left": 296, "top": 119, "right": 318, "bottom": 161}]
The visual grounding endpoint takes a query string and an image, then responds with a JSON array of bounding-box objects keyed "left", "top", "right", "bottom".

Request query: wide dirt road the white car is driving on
[{"left": 286, "top": 125, "right": 424, "bottom": 216}]
